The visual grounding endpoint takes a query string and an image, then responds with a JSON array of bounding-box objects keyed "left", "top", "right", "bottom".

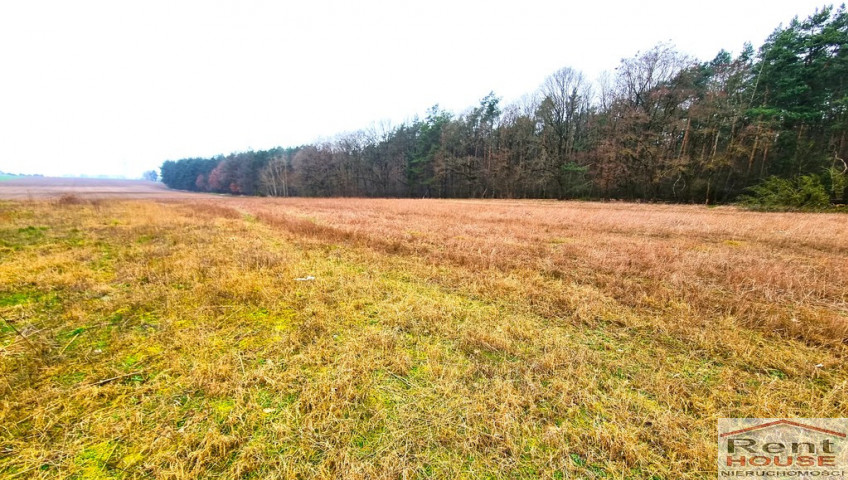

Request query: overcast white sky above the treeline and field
[{"left": 0, "top": 0, "right": 836, "bottom": 177}]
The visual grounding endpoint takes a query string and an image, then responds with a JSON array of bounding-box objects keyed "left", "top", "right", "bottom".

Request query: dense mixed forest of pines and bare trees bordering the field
[{"left": 161, "top": 5, "right": 848, "bottom": 207}]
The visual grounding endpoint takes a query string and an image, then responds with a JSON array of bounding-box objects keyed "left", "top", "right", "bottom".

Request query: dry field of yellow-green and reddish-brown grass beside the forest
[{"left": 0, "top": 181, "right": 848, "bottom": 480}]
